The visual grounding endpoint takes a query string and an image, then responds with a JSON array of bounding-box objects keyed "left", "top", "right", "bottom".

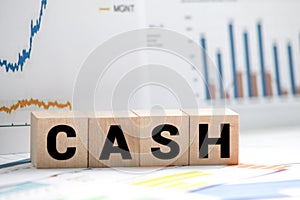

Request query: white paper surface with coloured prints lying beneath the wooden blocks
[{"left": 0, "top": 128, "right": 300, "bottom": 199}]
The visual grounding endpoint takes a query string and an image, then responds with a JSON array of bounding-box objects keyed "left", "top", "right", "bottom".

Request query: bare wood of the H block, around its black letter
[{"left": 184, "top": 109, "right": 239, "bottom": 165}]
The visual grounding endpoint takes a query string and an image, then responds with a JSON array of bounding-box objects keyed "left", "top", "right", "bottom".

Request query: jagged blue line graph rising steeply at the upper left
[{"left": 0, "top": 0, "right": 47, "bottom": 72}]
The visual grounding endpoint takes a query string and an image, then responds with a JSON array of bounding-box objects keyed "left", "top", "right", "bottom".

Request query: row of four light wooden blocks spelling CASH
[{"left": 30, "top": 109, "right": 239, "bottom": 168}]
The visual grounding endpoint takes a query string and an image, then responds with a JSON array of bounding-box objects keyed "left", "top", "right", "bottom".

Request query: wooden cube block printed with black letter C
[{"left": 30, "top": 112, "right": 88, "bottom": 168}]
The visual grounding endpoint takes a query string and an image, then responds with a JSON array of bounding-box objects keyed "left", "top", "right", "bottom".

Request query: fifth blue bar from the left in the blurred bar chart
[{"left": 257, "top": 23, "right": 268, "bottom": 97}]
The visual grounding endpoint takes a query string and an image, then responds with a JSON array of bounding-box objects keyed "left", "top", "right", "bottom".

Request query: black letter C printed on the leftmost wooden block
[{"left": 47, "top": 125, "right": 76, "bottom": 160}]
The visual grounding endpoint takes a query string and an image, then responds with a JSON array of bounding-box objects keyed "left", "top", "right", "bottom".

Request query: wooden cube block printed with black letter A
[{"left": 89, "top": 111, "right": 140, "bottom": 167}]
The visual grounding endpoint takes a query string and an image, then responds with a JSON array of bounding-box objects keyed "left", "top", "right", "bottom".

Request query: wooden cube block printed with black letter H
[{"left": 184, "top": 109, "right": 239, "bottom": 165}]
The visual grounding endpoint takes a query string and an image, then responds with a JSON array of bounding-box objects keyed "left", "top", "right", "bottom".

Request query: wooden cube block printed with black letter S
[{"left": 133, "top": 110, "right": 189, "bottom": 166}]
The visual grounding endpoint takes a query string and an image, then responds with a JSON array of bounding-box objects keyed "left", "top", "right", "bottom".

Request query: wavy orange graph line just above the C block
[{"left": 0, "top": 98, "right": 72, "bottom": 114}]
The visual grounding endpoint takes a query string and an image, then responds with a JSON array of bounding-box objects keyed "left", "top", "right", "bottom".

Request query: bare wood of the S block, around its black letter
[{"left": 133, "top": 110, "right": 189, "bottom": 166}]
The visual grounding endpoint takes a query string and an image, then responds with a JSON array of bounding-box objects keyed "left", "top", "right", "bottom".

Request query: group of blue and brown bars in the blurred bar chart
[{"left": 199, "top": 22, "right": 300, "bottom": 100}]
